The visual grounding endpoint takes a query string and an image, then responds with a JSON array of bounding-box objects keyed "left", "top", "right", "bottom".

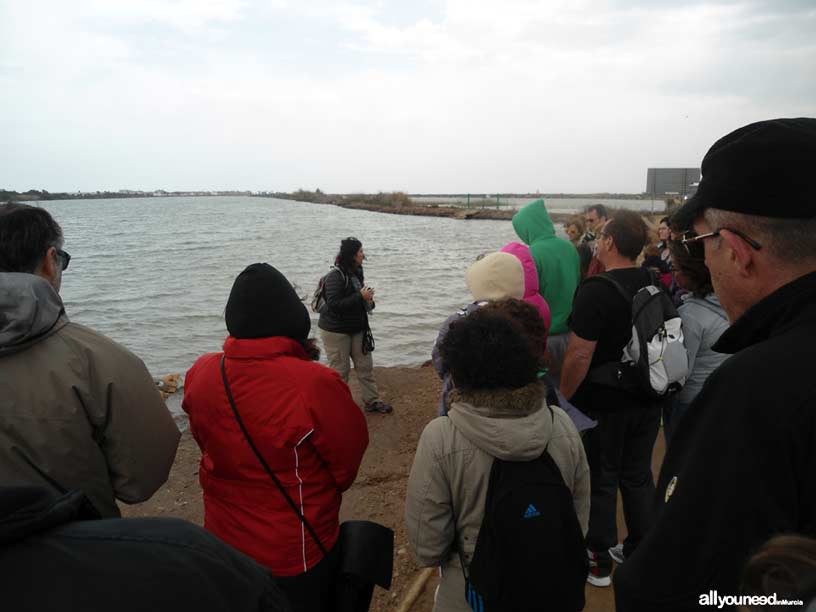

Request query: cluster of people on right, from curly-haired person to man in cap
[{"left": 406, "top": 119, "right": 816, "bottom": 611}]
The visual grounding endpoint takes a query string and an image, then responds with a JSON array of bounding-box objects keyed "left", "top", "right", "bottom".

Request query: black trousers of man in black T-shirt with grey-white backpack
[{"left": 576, "top": 389, "right": 661, "bottom": 556}]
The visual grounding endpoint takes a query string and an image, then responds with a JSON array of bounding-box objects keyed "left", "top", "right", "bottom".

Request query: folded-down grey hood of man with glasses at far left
[{"left": 0, "top": 272, "right": 68, "bottom": 356}]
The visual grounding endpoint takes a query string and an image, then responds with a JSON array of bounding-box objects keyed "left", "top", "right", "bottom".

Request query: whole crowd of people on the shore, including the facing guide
[{"left": 0, "top": 119, "right": 816, "bottom": 612}]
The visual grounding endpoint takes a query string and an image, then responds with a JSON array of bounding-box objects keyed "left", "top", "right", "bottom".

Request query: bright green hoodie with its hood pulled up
[{"left": 513, "top": 200, "right": 581, "bottom": 334}]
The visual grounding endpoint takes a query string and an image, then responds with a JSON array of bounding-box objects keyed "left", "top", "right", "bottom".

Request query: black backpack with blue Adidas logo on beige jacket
[{"left": 460, "top": 408, "right": 589, "bottom": 612}]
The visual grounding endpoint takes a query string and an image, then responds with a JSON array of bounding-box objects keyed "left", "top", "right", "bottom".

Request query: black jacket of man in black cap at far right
[{"left": 615, "top": 272, "right": 816, "bottom": 612}]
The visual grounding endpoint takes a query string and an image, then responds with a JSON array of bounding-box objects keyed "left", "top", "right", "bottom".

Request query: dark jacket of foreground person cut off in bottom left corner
[{"left": 0, "top": 487, "right": 291, "bottom": 612}]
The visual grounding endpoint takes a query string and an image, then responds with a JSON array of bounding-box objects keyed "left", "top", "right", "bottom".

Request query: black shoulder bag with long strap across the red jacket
[{"left": 221, "top": 355, "right": 394, "bottom": 612}]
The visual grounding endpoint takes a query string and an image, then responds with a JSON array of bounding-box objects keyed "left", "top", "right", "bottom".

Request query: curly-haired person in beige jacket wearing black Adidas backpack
[{"left": 405, "top": 300, "right": 589, "bottom": 612}]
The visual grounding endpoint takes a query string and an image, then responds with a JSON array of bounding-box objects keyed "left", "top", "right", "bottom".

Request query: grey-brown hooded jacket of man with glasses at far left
[{"left": 0, "top": 273, "right": 181, "bottom": 517}]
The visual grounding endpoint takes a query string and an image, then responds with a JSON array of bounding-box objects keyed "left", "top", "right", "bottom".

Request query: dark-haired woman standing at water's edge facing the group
[{"left": 317, "top": 238, "right": 391, "bottom": 412}]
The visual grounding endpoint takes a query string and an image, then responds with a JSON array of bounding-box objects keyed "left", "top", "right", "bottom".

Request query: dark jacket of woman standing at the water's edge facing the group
[{"left": 317, "top": 268, "right": 368, "bottom": 334}]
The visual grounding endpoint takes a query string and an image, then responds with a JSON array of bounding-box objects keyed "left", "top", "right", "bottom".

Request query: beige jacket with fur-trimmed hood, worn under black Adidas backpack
[{"left": 405, "top": 383, "right": 589, "bottom": 612}]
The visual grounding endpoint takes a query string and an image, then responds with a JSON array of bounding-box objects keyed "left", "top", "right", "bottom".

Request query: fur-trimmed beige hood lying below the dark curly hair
[{"left": 448, "top": 383, "right": 553, "bottom": 461}]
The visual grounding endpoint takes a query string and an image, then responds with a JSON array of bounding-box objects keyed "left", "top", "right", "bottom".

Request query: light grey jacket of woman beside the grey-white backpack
[{"left": 674, "top": 293, "right": 728, "bottom": 405}]
